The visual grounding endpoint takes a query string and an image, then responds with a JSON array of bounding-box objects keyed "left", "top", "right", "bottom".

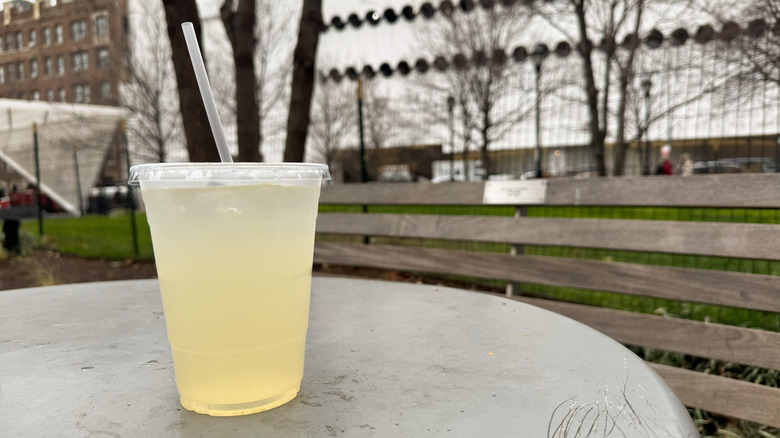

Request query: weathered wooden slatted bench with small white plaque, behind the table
[{"left": 314, "top": 174, "right": 780, "bottom": 427}]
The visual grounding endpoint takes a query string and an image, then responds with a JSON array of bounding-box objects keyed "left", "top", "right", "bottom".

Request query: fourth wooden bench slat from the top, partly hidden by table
[{"left": 514, "top": 297, "right": 780, "bottom": 372}]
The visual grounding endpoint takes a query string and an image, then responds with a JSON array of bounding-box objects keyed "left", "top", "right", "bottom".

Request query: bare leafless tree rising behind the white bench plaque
[{"left": 419, "top": 6, "right": 532, "bottom": 173}]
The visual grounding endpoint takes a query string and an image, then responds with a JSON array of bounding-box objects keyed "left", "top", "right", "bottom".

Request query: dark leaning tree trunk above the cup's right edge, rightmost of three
[{"left": 284, "top": 0, "right": 322, "bottom": 162}]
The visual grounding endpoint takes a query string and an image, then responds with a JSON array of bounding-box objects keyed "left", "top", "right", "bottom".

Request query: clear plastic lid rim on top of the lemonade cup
[{"left": 128, "top": 163, "right": 330, "bottom": 186}]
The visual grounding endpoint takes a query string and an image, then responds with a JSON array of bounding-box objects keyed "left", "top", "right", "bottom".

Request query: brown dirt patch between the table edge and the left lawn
[{"left": 0, "top": 250, "right": 157, "bottom": 290}]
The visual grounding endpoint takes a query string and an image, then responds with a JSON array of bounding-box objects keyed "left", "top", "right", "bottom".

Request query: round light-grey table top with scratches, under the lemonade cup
[{"left": 0, "top": 277, "right": 698, "bottom": 438}]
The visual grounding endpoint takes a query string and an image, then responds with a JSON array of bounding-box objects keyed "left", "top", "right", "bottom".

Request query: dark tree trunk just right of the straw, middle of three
[{"left": 219, "top": 0, "right": 262, "bottom": 162}]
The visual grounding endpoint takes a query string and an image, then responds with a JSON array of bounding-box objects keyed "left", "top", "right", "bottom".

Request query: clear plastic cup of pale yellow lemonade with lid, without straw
[{"left": 130, "top": 163, "right": 330, "bottom": 416}]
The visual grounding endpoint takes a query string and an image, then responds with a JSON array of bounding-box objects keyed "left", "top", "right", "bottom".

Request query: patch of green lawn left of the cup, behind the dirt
[{"left": 22, "top": 213, "right": 154, "bottom": 260}]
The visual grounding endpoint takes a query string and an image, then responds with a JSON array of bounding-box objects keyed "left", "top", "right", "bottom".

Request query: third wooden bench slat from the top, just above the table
[{"left": 314, "top": 242, "right": 780, "bottom": 312}]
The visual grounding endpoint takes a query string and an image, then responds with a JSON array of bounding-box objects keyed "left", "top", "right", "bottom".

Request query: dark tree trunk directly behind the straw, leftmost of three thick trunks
[{"left": 163, "top": 0, "right": 219, "bottom": 162}]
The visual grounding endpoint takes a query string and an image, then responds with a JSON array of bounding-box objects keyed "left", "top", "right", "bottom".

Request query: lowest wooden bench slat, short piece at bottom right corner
[{"left": 650, "top": 364, "right": 780, "bottom": 427}]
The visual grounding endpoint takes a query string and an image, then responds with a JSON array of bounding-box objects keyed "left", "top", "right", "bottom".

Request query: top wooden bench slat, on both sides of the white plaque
[{"left": 320, "top": 173, "right": 780, "bottom": 208}]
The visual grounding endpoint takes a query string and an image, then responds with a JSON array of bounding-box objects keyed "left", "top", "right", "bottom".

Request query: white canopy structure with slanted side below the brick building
[{"left": 0, "top": 99, "right": 125, "bottom": 216}]
